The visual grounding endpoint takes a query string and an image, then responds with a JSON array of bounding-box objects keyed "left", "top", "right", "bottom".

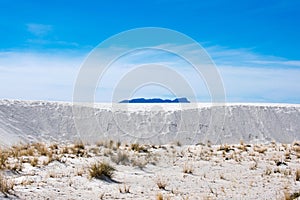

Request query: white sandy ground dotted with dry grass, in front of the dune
[{"left": 0, "top": 141, "right": 300, "bottom": 199}]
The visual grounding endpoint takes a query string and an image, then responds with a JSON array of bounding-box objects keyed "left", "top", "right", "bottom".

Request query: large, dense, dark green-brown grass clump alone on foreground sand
[{"left": 89, "top": 162, "right": 116, "bottom": 180}]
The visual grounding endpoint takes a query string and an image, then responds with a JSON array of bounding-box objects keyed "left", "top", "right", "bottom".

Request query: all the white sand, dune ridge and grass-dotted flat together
[{"left": 0, "top": 100, "right": 300, "bottom": 199}]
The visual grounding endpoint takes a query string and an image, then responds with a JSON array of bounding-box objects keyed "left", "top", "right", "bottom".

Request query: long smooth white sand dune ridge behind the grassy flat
[{"left": 0, "top": 100, "right": 300, "bottom": 146}]
